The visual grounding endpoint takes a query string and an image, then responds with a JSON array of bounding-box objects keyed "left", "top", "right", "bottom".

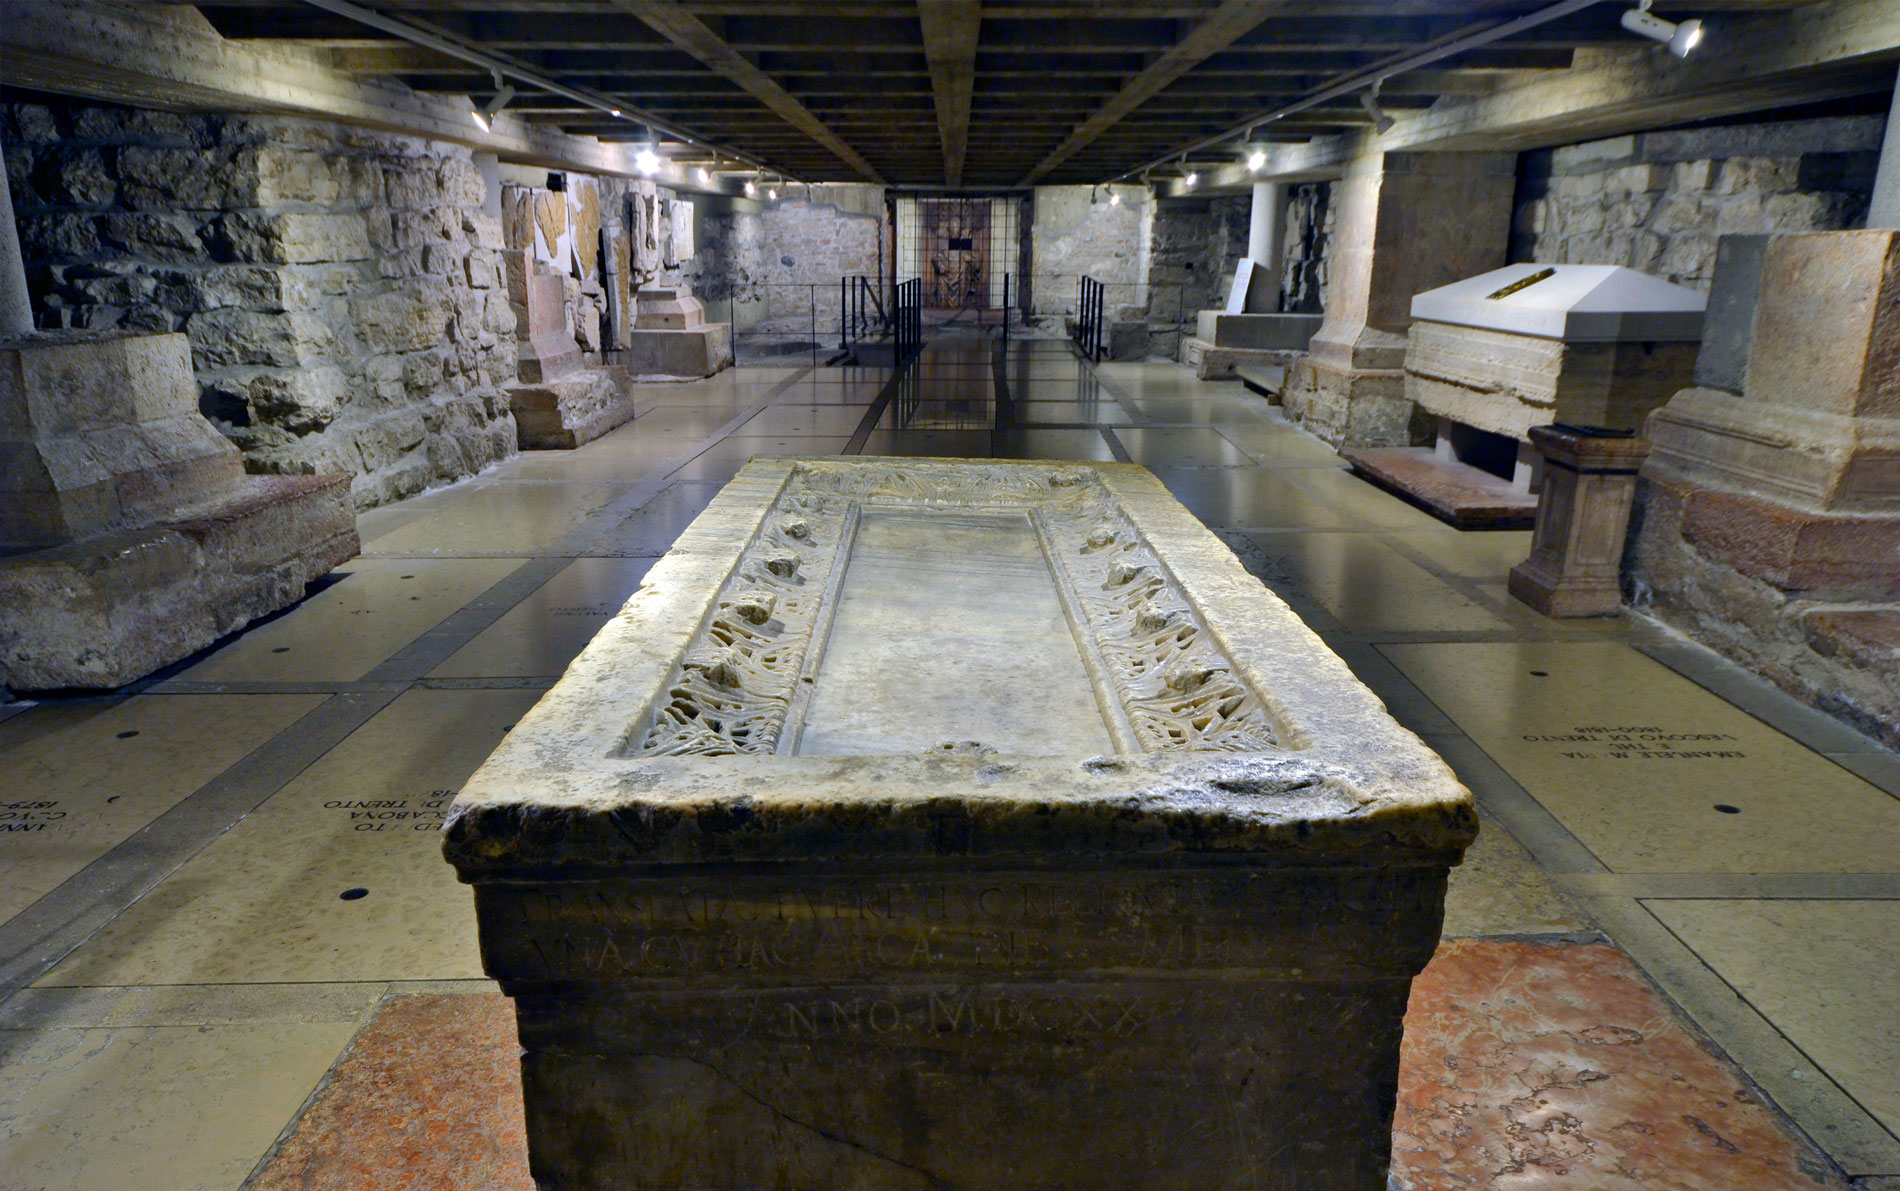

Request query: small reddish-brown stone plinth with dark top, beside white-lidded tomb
[{"left": 1511, "top": 425, "right": 1649, "bottom": 617}]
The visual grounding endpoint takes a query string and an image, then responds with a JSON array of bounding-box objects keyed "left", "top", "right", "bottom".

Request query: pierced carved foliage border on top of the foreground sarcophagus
[{"left": 629, "top": 462, "right": 1277, "bottom": 754}]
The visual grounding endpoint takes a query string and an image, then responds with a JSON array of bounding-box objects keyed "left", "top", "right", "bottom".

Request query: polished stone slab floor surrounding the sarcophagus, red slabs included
[{"left": 0, "top": 338, "right": 1900, "bottom": 1191}]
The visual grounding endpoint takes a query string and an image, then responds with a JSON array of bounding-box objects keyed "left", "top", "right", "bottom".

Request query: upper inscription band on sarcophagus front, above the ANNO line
[{"left": 488, "top": 874, "right": 1440, "bottom": 984}]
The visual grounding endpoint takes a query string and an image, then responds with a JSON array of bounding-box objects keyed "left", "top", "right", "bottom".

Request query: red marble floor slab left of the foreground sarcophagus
[{"left": 247, "top": 993, "right": 534, "bottom": 1191}]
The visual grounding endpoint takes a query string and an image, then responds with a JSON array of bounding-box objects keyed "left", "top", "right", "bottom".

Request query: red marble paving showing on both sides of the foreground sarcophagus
[{"left": 251, "top": 938, "right": 1845, "bottom": 1191}]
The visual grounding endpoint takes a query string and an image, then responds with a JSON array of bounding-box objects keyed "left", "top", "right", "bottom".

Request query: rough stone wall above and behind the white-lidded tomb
[{"left": 1511, "top": 116, "right": 1885, "bottom": 293}]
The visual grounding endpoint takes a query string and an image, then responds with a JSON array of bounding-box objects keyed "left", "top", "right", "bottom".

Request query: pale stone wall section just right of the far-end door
[{"left": 1030, "top": 186, "right": 1147, "bottom": 315}]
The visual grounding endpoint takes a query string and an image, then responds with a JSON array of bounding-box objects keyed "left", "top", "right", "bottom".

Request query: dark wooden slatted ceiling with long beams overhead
[{"left": 189, "top": 0, "right": 1799, "bottom": 188}]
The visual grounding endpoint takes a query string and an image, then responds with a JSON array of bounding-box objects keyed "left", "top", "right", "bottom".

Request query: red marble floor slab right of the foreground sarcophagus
[{"left": 1393, "top": 940, "right": 1845, "bottom": 1191}]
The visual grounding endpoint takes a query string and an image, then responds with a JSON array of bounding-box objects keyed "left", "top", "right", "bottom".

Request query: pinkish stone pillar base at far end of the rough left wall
[{"left": 505, "top": 249, "right": 635, "bottom": 450}]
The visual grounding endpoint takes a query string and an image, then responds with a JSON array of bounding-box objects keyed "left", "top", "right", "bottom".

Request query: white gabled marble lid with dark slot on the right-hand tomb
[{"left": 1412, "top": 264, "right": 1708, "bottom": 344}]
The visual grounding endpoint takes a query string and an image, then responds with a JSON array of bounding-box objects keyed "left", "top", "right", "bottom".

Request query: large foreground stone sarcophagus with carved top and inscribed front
[{"left": 445, "top": 458, "right": 1476, "bottom": 1191}]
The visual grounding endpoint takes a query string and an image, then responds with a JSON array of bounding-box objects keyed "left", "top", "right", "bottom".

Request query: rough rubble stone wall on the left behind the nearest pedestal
[{"left": 0, "top": 104, "right": 515, "bottom": 507}]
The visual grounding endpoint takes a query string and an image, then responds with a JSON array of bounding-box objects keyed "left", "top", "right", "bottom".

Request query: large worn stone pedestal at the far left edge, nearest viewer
[{"left": 0, "top": 332, "right": 357, "bottom": 691}]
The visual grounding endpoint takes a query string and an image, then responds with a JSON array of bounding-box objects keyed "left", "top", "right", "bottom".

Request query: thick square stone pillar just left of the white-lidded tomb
[{"left": 1284, "top": 152, "right": 1516, "bottom": 446}]
